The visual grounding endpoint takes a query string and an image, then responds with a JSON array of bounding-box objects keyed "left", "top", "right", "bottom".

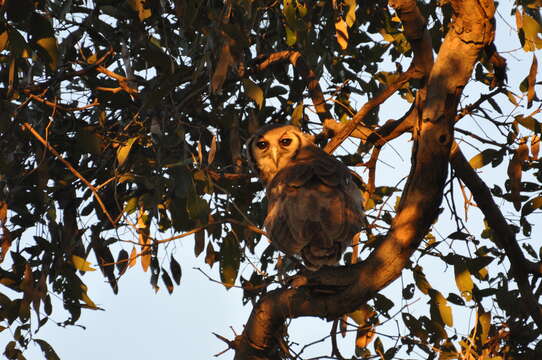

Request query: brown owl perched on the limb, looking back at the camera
[{"left": 247, "top": 125, "right": 363, "bottom": 270}]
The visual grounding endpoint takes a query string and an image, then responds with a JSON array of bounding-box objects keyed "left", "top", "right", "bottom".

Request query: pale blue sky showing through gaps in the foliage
[{"left": 0, "top": 1, "right": 541, "bottom": 360}]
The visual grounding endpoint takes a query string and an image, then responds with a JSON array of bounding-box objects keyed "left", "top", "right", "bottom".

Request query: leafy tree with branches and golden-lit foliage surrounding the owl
[{"left": 0, "top": 0, "right": 542, "bottom": 359}]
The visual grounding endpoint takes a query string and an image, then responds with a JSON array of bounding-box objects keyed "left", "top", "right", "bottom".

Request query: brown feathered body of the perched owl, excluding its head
[{"left": 265, "top": 146, "right": 363, "bottom": 269}]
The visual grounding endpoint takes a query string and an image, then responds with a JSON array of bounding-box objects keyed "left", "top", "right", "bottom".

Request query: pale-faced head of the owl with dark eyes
[{"left": 247, "top": 124, "right": 314, "bottom": 184}]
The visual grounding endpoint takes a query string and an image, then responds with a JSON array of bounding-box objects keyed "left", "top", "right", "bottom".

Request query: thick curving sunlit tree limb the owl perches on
[{"left": 235, "top": 0, "right": 495, "bottom": 360}]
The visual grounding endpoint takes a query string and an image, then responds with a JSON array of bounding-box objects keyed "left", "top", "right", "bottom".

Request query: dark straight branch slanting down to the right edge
[{"left": 450, "top": 144, "right": 542, "bottom": 329}]
